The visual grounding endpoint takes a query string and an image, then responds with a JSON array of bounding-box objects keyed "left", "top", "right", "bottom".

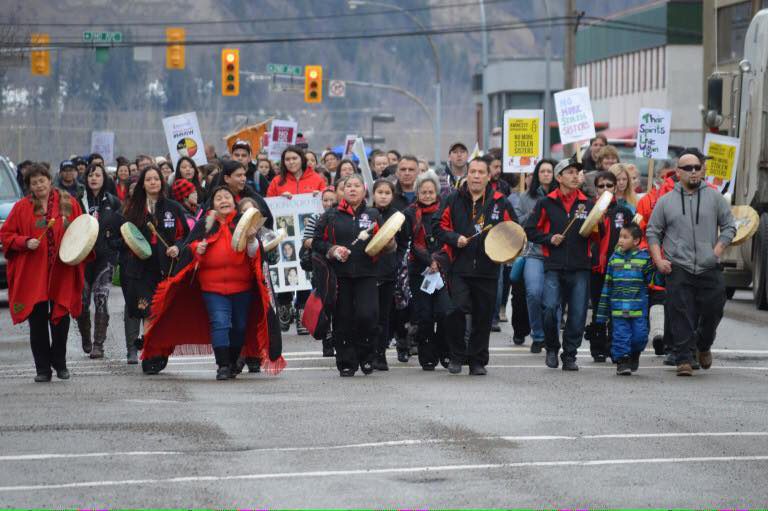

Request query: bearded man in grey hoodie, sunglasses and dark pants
[{"left": 646, "top": 148, "right": 736, "bottom": 376}]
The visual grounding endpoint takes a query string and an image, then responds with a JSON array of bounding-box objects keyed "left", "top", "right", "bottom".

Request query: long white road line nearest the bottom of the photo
[{"left": 0, "top": 456, "right": 768, "bottom": 493}]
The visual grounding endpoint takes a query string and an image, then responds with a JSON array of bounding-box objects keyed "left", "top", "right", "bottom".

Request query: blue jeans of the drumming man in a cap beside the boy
[{"left": 544, "top": 270, "right": 590, "bottom": 359}]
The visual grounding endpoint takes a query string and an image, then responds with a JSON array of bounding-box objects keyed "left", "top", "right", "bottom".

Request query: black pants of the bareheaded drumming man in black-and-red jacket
[{"left": 446, "top": 275, "right": 498, "bottom": 366}]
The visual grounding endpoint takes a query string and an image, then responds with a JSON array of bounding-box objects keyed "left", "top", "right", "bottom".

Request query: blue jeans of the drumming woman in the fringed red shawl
[{"left": 203, "top": 291, "right": 253, "bottom": 348}]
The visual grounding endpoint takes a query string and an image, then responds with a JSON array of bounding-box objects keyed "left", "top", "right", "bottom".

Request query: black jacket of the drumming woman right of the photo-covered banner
[{"left": 312, "top": 200, "right": 379, "bottom": 278}]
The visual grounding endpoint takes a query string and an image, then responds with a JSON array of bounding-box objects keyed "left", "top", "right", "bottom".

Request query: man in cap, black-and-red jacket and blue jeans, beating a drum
[{"left": 525, "top": 159, "right": 599, "bottom": 371}]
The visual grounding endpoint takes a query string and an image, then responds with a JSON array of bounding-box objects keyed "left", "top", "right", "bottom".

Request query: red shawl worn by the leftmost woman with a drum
[{"left": 0, "top": 190, "right": 89, "bottom": 324}]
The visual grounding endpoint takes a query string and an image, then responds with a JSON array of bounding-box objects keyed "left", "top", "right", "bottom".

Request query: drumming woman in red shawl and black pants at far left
[{"left": 0, "top": 164, "right": 84, "bottom": 382}]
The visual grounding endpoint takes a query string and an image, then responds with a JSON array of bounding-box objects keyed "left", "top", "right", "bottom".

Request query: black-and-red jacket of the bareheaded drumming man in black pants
[{"left": 432, "top": 183, "right": 517, "bottom": 279}]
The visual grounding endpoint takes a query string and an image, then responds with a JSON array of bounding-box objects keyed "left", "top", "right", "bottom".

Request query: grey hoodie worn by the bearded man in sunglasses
[{"left": 646, "top": 181, "right": 736, "bottom": 275}]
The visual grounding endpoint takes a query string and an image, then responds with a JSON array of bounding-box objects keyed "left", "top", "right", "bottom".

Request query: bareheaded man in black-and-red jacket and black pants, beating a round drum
[{"left": 433, "top": 158, "right": 517, "bottom": 375}]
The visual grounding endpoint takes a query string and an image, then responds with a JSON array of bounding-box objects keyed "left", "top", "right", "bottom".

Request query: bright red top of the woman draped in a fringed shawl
[{"left": 189, "top": 212, "right": 253, "bottom": 295}]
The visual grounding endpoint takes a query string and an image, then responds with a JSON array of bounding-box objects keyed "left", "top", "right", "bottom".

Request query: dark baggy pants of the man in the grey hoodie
[{"left": 665, "top": 266, "right": 726, "bottom": 364}]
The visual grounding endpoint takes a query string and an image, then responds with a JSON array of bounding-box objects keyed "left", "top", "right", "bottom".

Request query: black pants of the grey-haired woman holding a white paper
[{"left": 410, "top": 274, "right": 451, "bottom": 367}]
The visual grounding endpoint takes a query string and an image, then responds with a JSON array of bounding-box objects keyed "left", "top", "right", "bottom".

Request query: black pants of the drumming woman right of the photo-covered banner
[{"left": 333, "top": 277, "right": 379, "bottom": 371}]
